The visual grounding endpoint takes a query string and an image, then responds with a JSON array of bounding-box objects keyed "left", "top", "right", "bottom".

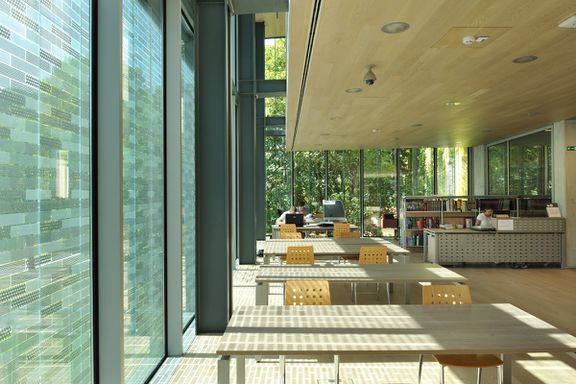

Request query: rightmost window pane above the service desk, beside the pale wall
[{"left": 509, "top": 130, "right": 552, "bottom": 196}]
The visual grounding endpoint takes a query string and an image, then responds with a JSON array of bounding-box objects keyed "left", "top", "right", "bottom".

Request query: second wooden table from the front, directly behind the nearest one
[{"left": 255, "top": 263, "right": 467, "bottom": 305}]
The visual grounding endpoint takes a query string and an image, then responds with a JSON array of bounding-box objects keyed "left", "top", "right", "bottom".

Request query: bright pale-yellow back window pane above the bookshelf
[{"left": 436, "top": 147, "right": 468, "bottom": 196}]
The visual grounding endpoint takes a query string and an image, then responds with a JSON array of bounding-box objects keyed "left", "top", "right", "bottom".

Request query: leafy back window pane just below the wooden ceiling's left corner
[{"left": 294, "top": 152, "right": 326, "bottom": 218}]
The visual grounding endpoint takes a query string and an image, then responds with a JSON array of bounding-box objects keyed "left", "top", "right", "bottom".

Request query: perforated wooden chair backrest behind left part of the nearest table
[{"left": 284, "top": 280, "right": 331, "bottom": 305}]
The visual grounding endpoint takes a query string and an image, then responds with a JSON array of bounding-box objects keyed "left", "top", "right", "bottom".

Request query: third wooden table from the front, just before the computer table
[{"left": 264, "top": 237, "right": 410, "bottom": 264}]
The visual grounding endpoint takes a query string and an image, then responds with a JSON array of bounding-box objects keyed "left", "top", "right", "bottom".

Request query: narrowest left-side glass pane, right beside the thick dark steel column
[{"left": 181, "top": 19, "right": 196, "bottom": 328}]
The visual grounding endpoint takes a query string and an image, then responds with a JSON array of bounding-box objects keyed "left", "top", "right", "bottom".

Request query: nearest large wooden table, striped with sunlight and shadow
[{"left": 216, "top": 304, "right": 576, "bottom": 384}]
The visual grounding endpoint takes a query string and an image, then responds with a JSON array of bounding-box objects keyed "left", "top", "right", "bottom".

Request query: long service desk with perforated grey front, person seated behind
[{"left": 424, "top": 217, "right": 565, "bottom": 264}]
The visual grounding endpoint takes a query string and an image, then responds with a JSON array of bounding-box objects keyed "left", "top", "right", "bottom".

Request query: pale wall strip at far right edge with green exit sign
[{"left": 552, "top": 120, "right": 576, "bottom": 268}]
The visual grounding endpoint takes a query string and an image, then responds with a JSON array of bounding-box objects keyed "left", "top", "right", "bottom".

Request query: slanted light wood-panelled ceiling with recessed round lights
[{"left": 286, "top": 0, "right": 576, "bottom": 150}]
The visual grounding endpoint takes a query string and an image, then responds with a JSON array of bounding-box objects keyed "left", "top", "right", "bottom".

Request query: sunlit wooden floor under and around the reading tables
[{"left": 152, "top": 255, "right": 576, "bottom": 384}]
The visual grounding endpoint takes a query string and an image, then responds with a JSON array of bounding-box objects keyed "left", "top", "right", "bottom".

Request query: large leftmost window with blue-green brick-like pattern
[{"left": 0, "top": 0, "right": 94, "bottom": 383}]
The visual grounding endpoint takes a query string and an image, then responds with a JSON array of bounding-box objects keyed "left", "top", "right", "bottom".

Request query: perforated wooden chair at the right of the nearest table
[{"left": 418, "top": 285, "right": 504, "bottom": 384}]
